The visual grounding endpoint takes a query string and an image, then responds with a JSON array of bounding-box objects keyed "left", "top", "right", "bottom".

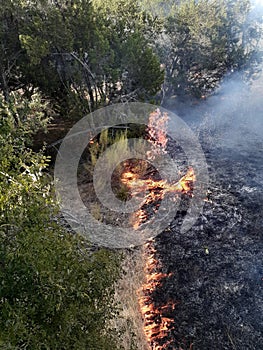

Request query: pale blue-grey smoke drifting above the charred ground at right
[{"left": 173, "top": 0, "right": 263, "bottom": 163}]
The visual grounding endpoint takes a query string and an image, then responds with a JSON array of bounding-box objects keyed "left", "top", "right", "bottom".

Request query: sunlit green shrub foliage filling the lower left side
[{"left": 0, "top": 95, "right": 119, "bottom": 350}]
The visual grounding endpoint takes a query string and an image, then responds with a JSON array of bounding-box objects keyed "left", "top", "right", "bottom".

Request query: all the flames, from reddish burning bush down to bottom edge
[{"left": 121, "top": 109, "right": 196, "bottom": 350}]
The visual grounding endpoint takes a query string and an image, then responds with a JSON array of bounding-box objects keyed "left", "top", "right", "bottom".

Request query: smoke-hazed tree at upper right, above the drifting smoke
[{"left": 158, "top": 0, "right": 260, "bottom": 97}]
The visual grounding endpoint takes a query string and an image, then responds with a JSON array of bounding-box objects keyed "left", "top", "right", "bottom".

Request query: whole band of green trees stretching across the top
[{"left": 0, "top": 0, "right": 261, "bottom": 107}]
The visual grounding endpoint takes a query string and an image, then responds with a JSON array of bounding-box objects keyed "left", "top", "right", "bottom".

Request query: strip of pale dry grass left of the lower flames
[{"left": 112, "top": 248, "right": 149, "bottom": 350}]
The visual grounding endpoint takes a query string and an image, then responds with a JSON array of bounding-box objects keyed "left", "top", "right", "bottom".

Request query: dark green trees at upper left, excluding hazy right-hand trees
[{"left": 0, "top": 0, "right": 163, "bottom": 118}]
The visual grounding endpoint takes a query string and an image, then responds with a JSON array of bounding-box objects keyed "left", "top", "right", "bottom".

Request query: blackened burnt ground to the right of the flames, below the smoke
[{"left": 148, "top": 98, "right": 263, "bottom": 350}]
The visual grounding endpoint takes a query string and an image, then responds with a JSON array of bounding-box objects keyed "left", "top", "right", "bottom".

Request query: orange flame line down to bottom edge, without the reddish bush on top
[{"left": 121, "top": 164, "right": 195, "bottom": 350}]
